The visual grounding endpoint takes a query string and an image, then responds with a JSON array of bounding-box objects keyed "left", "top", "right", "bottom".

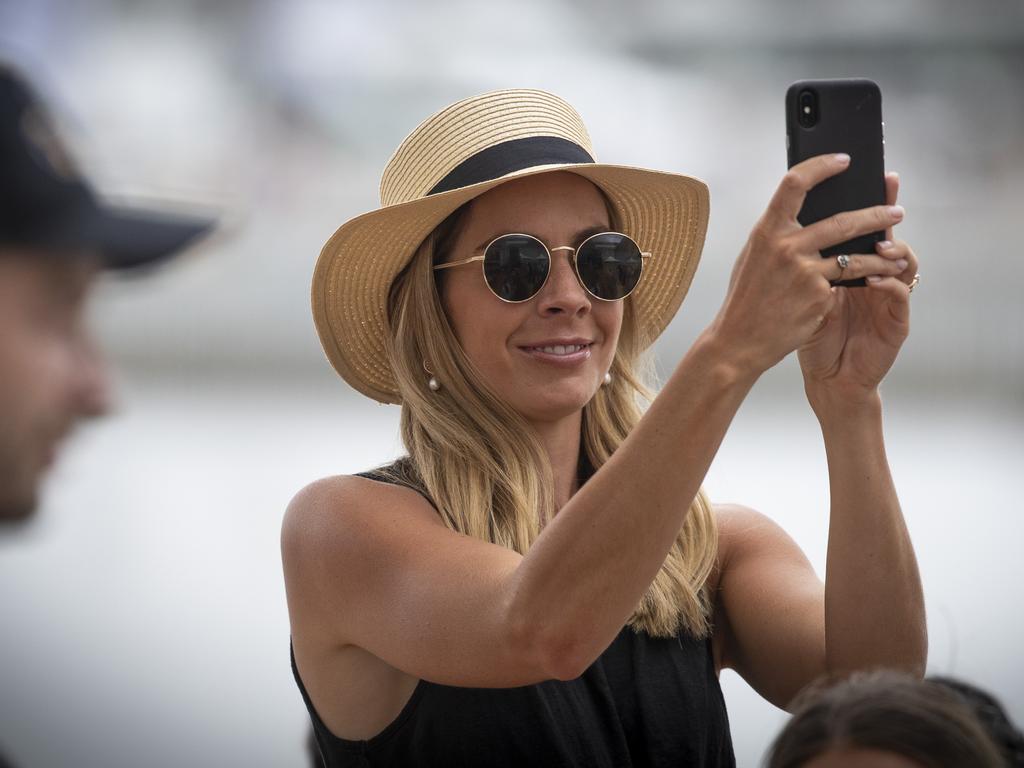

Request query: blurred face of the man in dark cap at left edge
[{"left": 0, "top": 249, "right": 109, "bottom": 523}]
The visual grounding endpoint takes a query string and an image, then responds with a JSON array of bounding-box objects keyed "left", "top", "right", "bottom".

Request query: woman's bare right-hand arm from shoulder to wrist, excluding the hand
[{"left": 715, "top": 403, "right": 928, "bottom": 709}]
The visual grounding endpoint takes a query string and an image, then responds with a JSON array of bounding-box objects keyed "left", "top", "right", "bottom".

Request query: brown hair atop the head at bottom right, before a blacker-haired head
[{"left": 765, "top": 672, "right": 1004, "bottom": 768}]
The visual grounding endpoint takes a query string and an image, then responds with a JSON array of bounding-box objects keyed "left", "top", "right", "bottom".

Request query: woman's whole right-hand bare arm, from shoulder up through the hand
[{"left": 719, "top": 167, "right": 928, "bottom": 707}]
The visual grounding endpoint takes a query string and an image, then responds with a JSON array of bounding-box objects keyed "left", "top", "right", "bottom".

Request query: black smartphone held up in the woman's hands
[{"left": 785, "top": 78, "right": 886, "bottom": 287}]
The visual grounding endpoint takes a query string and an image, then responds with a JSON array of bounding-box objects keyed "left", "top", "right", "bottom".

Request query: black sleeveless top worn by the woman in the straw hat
[{"left": 292, "top": 465, "right": 735, "bottom": 768}]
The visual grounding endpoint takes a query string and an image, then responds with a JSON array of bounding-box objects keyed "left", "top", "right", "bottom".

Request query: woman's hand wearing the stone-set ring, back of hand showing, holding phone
[{"left": 709, "top": 155, "right": 903, "bottom": 376}]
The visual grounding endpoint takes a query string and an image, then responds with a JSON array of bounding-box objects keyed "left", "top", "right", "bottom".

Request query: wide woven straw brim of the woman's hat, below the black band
[{"left": 311, "top": 163, "right": 709, "bottom": 403}]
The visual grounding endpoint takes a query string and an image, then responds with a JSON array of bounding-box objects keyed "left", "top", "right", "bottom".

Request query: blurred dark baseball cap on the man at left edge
[{"left": 0, "top": 62, "right": 214, "bottom": 269}]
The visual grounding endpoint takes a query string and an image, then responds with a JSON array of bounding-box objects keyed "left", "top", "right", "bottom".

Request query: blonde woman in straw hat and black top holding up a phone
[{"left": 283, "top": 90, "right": 926, "bottom": 766}]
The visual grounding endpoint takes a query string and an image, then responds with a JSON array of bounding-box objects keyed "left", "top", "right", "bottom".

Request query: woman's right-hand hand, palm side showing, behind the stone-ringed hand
[{"left": 798, "top": 173, "right": 918, "bottom": 407}]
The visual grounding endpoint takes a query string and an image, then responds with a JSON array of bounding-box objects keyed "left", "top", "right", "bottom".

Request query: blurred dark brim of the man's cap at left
[{"left": 47, "top": 202, "right": 216, "bottom": 269}]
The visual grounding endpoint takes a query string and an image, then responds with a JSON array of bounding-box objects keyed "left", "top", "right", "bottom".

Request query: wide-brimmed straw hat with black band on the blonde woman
[{"left": 312, "top": 89, "right": 709, "bottom": 402}]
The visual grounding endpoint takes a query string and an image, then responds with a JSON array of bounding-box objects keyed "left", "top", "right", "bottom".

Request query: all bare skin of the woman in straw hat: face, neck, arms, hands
[{"left": 282, "top": 157, "right": 927, "bottom": 738}]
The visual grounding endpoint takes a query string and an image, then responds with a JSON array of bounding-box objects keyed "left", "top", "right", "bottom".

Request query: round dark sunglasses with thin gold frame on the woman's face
[{"left": 434, "top": 232, "right": 650, "bottom": 304}]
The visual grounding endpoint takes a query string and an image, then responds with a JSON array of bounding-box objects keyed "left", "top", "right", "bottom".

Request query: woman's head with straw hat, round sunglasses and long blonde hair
[{"left": 313, "top": 91, "right": 715, "bottom": 636}]
